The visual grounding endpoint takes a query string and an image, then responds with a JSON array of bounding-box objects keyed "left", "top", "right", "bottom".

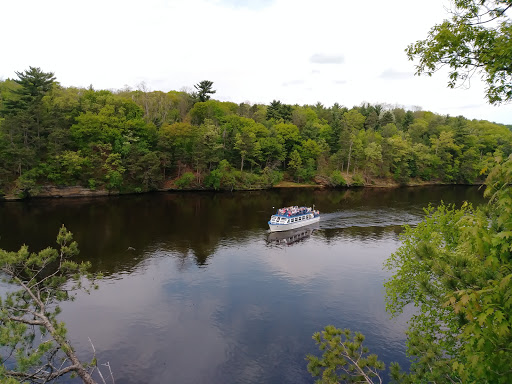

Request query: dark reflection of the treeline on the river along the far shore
[{"left": 0, "top": 186, "right": 481, "bottom": 275}]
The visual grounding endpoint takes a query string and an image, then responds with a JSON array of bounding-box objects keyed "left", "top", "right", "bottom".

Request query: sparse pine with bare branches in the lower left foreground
[{"left": 0, "top": 226, "right": 108, "bottom": 384}]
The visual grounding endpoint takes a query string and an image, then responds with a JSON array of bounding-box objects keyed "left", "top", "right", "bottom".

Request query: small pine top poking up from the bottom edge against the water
[{"left": 306, "top": 325, "right": 385, "bottom": 384}]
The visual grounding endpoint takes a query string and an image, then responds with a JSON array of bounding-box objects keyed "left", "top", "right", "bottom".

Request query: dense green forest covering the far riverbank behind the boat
[{"left": 0, "top": 67, "right": 512, "bottom": 194}]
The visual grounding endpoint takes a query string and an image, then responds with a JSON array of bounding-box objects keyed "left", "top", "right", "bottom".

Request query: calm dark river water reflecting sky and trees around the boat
[{"left": 0, "top": 186, "right": 483, "bottom": 384}]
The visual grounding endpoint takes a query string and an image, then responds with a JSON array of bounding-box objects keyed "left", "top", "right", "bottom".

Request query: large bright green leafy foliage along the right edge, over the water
[{"left": 385, "top": 156, "right": 512, "bottom": 383}]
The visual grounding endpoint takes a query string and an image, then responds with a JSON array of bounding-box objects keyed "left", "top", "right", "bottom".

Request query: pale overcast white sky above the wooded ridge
[{"left": 0, "top": 0, "right": 512, "bottom": 124}]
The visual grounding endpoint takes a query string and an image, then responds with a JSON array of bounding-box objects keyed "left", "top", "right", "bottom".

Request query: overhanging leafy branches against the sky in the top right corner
[{"left": 406, "top": 0, "right": 512, "bottom": 104}]
